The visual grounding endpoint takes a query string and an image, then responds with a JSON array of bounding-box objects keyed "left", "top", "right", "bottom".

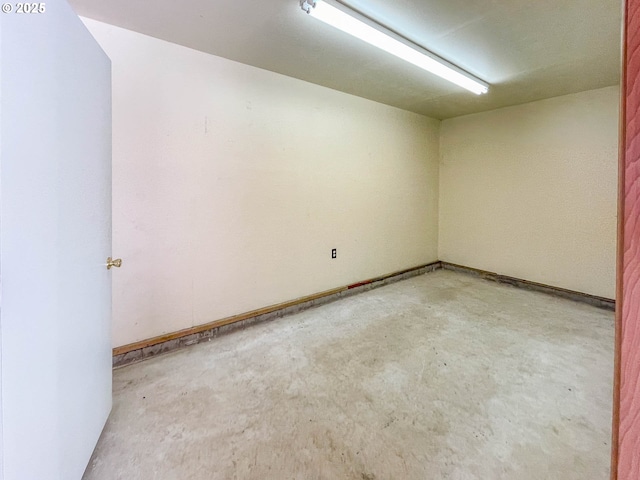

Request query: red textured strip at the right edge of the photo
[{"left": 614, "top": 0, "right": 640, "bottom": 480}]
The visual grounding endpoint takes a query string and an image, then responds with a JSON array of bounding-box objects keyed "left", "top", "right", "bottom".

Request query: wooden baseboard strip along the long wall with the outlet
[{"left": 113, "top": 262, "right": 441, "bottom": 368}]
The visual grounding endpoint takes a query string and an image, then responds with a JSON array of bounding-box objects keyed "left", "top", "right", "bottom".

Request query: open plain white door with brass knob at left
[{"left": 0, "top": 0, "right": 117, "bottom": 480}]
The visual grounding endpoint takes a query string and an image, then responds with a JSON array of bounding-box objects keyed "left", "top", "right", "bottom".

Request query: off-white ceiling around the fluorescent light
[{"left": 70, "top": 0, "right": 622, "bottom": 119}]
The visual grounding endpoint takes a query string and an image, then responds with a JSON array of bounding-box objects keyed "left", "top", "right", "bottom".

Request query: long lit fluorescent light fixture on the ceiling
[{"left": 300, "top": 0, "right": 489, "bottom": 95}]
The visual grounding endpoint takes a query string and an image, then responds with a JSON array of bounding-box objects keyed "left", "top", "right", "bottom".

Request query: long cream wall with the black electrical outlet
[{"left": 85, "top": 20, "right": 440, "bottom": 346}]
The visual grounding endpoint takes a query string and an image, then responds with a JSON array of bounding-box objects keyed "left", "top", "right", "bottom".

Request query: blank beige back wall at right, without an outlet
[{"left": 439, "top": 87, "right": 618, "bottom": 298}]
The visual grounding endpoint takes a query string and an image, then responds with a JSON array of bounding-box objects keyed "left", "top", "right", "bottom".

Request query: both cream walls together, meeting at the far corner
[{"left": 85, "top": 20, "right": 618, "bottom": 346}]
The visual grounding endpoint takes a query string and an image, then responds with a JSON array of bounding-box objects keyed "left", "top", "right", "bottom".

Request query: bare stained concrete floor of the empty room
[{"left": 84, "top": 271, "right": 614, "bottom": 480}]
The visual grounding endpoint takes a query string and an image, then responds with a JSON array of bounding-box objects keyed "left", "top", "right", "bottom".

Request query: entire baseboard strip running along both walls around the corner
[{"left": 113, "top": 261, "right": 615, "bottom": 368}]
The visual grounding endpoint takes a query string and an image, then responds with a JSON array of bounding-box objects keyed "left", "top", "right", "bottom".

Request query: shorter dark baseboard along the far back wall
[{"left": 440, "top": 262, "right": 616, "bottom": 311}]
